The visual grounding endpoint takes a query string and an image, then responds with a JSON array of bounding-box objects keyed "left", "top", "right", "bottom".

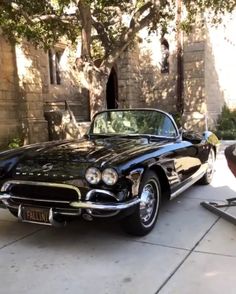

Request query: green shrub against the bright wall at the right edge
[{"left": 215, "top": 105, "right": 236, "bottom": 140}]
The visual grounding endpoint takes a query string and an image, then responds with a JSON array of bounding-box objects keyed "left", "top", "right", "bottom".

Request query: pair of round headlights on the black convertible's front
[{"left": 85, "top": 167, "right": 118, "bottom": 186}]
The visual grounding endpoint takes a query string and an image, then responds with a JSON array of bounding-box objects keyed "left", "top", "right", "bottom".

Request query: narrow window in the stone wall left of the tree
[{"left": 48, "top": 49, "right": 63, "bottom": 85}]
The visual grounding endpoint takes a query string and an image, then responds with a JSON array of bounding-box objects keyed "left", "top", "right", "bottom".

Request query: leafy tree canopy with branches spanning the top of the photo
[{"left": 0, "top": 0, "right": 236, "bottom": 64}]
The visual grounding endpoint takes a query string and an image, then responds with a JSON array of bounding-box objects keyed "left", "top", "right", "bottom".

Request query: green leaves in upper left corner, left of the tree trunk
[{"left": 0, "top": 0, "right": 80, "bottom": 48}]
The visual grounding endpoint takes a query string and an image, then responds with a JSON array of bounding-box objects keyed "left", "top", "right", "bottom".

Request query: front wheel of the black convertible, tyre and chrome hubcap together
[{"left": 123, "top": 171, "right": 161, "bottom": 236}]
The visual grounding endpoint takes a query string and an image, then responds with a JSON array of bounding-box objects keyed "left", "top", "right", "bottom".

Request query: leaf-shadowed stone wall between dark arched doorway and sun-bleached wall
[{"left": 118, "top": 29, "right": 208, "bottom": 130}]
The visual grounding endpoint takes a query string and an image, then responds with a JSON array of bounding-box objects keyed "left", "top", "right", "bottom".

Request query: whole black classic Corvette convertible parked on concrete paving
[{"left": 0, "top": 109, "right": 218, "bottom": 236}]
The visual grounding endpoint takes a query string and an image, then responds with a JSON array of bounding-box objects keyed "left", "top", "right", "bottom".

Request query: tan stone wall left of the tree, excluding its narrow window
[{"left": 0, "top": 37, "right": 89, "bottom": 146}]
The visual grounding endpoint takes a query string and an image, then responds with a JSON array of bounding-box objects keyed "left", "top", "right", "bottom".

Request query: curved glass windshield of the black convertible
[{"left": 89, "top": 110, "right": 177, "bottom": 138}]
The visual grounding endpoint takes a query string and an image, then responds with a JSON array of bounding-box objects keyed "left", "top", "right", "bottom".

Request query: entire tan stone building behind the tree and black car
[{"left": 0, "top": 9, "right": 236, "bottom": 146}]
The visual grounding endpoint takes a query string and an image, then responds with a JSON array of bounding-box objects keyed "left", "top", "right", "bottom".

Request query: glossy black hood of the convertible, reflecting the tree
[{"left": 0, "top": 138, "right": 173, "bottom": 179}]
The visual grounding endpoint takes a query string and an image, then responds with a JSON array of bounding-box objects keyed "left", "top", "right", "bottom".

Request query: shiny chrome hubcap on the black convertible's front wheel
[{"left": 140, "top": 180, "right": 159, "bottom": 226}]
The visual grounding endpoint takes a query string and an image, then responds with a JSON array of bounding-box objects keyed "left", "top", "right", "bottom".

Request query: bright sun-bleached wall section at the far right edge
[{"left": 204, "top": 11, "right": 236, "bottom": 125}]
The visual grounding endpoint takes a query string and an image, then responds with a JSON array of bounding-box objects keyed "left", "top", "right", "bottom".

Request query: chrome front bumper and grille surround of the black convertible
[{"left": 0, "top": 180, "right": 140, "bottom": 225}]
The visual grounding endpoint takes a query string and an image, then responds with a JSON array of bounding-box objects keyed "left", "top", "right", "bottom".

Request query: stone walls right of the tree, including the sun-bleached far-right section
[{"left": 118, "top": 11, "right": 236, "bottom": 130}]
